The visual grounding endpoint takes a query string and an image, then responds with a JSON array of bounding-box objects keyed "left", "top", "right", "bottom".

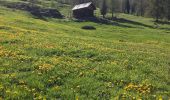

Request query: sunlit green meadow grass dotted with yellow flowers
[{"left": 0, "top": 7, "right": 170, "bottom": 100}]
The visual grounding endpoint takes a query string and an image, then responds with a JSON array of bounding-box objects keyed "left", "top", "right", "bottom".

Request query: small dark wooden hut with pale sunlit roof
[{"left": 72, "top": 2, "right": 96, "bottom": 18}]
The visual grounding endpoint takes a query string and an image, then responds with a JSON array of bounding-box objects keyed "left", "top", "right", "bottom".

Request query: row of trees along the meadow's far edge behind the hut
[{"left": 27, "top": 0, "right": 170, "bottom": 21}]
